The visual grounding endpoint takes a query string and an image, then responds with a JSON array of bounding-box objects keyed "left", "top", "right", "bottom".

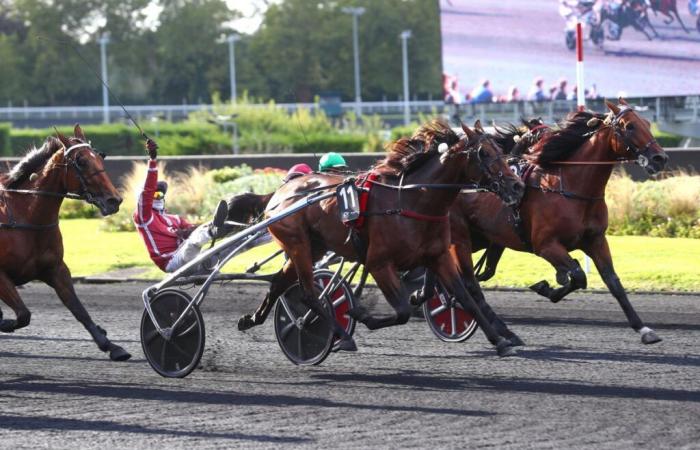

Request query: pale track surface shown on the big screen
[{"left": 440, "top": 0, "right": 700, "bottom": 98}]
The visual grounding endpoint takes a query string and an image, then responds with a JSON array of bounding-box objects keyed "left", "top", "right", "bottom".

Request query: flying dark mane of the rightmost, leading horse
[{"left": 533, "top": 111, "right": 606, "bottom": 167}]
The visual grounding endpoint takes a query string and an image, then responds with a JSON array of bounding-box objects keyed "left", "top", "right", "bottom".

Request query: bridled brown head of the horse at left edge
[{"left": 56, "top": 125, "right": 122, "bottom": 216}]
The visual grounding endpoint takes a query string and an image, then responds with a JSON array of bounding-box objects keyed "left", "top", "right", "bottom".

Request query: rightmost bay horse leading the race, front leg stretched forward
[{"left": 414, "top": 99, "right": 668, "bottom": 344}]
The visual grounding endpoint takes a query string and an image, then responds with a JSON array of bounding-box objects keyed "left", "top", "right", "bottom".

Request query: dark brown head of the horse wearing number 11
[{"left": 440, "top": 120, "right": 525, "bottom": 206}]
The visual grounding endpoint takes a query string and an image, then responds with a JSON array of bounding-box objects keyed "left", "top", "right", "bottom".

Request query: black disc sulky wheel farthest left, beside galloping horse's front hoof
[{"left": 141, "top": 289, "right": 204, "bottom": 378}]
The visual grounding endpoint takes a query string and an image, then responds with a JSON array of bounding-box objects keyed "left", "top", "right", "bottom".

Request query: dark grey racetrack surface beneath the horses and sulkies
[{"left": 0, "top": 283, "right": 700, "bottom": 449}]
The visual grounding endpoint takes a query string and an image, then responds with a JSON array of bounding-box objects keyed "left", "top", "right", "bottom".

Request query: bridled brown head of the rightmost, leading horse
[{"left": 605, "top": 98, "right": 669, "bottom": 175}]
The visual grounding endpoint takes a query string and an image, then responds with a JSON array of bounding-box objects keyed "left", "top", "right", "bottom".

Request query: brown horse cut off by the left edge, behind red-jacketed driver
[{"left": 0, "top": 125, "right": 131, "bottom": 361}]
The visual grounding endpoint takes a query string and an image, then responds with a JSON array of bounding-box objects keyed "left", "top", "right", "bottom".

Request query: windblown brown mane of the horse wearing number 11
[{"left": 374, "top": 119, "right": 459, "bottom": 175}]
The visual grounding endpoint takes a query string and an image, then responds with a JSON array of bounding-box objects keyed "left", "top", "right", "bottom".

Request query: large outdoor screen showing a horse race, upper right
[{"left": 440, "top": 0, "right": 700, "bottom": 103}]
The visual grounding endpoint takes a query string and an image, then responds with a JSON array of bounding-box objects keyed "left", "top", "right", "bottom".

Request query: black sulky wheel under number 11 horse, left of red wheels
[{"left": 275, "top": 283, "right": 334, "bottom": 365}]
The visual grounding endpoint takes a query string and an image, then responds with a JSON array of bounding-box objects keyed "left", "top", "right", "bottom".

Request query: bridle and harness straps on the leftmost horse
[{"left": 0, "top": 142, "right": 105, "bottom": 230}]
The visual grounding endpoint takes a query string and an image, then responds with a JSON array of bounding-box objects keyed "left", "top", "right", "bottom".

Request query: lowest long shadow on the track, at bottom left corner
[{"left": 0, "top": 414, "right": 313, "bottom": 444}]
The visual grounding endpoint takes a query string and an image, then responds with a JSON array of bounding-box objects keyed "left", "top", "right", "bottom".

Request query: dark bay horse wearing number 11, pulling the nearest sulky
[{"left": 239, "top": 121, "right": 524, "bottom": 356}]
